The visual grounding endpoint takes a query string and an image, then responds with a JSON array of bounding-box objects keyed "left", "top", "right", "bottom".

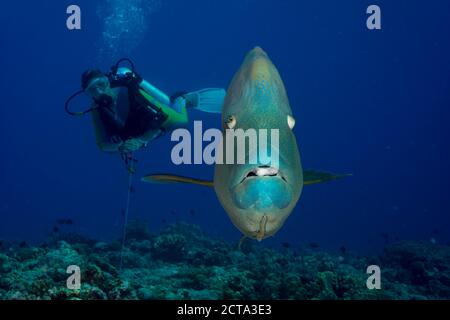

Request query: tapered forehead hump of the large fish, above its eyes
[{"left": 222, "top": 47, "right": 292, "bottom": 121}]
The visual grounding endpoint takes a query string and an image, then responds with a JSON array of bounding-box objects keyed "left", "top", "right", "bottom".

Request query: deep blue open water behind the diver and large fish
[{"left": 0, "top": 0, "right": 450, "bottom": 252}]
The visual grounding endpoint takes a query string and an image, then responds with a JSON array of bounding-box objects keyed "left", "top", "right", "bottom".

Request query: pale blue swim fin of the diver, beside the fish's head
[{"left": 186, "top": 88, "right": 227, "bottom": 113}]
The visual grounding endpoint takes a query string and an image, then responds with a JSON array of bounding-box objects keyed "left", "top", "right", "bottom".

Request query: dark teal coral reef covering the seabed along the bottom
[{"left": 0, "top": 222, "right": 450, "bottom": 300}]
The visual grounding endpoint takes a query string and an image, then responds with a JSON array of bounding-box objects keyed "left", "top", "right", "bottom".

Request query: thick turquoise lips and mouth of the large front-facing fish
[{"left": 230, "top": 166, "right": 292, "bottom": 212}]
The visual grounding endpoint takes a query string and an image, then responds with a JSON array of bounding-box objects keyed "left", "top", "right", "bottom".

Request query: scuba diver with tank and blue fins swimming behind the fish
[{"left": 65, "top": 58, "right": 226, "bottom": 155}]
